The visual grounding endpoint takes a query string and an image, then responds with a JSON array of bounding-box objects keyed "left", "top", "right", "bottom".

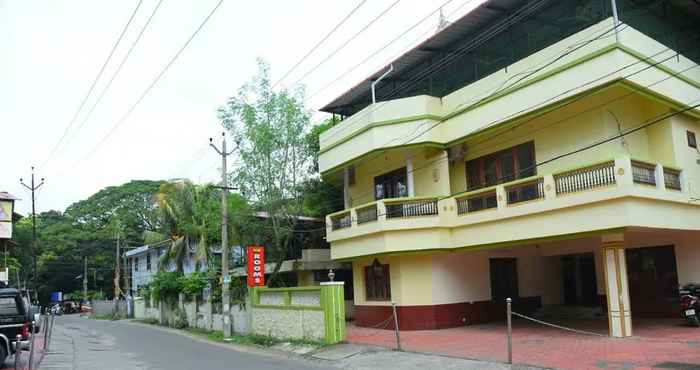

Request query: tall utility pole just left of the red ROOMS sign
[{"left": 209, "top": 133, "right": 233, "bottom": 338}]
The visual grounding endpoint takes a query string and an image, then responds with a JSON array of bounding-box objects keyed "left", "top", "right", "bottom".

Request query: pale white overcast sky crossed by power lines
[{"left": 0, "top": 0, "right": 483, "bottom": 214}]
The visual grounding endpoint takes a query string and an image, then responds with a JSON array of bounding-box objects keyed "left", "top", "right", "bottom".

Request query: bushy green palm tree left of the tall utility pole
[{"left": 156, "top": 180, "right": 220, "bottom": 272}]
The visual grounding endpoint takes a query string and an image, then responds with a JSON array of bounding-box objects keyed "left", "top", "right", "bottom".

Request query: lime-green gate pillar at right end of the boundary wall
[{"left": 321, "top": 281, "right": 345, "bottom": 344}]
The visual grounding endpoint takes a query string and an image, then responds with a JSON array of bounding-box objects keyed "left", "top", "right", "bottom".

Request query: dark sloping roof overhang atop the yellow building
[{"left": 320, "top": 0, "right": 533, "bottom": 115}]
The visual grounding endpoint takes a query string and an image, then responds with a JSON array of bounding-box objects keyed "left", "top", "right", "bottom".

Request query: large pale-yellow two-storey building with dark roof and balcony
[{"left": 319, "top": 0, "right": 700, "bottom": 336}]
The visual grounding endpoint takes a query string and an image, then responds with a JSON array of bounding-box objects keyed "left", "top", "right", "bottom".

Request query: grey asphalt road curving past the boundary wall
[{"left": 41, "top": 315, "right": 332, "bottom": 370}]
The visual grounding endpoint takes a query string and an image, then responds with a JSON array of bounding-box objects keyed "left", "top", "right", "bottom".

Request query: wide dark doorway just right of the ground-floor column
[{"left": 625, "top": 245, "right": 679, "bottom": 317}]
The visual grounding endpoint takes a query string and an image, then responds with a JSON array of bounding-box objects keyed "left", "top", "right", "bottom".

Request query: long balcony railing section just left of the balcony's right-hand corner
[{"left": 554, "top": 161, "right": 615, "bottom": 195}]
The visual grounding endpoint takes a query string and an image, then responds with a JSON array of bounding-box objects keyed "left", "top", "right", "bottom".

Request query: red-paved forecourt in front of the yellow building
[{"left": 347, "top": 317, "right": 700, "bottom": 370}]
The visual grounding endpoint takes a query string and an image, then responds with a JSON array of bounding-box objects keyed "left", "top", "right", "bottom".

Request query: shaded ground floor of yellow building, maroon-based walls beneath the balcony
[{"left": 353, "top": 228, "right": 700, "bottom": 337}]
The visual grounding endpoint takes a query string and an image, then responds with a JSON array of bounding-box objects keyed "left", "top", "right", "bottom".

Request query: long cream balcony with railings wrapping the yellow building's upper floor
[{"left": 327, "top": 158, "right": 689, "bottom": 258}]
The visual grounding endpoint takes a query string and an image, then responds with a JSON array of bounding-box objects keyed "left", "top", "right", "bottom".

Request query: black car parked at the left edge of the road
[{"left": 0, "top": 288, "right": 30, "bottom": 363}]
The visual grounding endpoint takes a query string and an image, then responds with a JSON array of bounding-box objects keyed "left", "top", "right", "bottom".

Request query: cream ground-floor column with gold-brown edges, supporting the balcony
[{"left": 602, "top": 234, "right": 632, "bottom": 338}]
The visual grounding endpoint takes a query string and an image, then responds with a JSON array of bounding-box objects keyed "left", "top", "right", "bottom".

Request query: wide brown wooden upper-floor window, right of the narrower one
[{"left": 466, "top": 141, "right": 537, "bottom": 190}]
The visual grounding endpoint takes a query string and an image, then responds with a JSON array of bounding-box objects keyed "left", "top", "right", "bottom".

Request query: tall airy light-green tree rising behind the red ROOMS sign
[{"left": 219, "top": 60, "right": 312, "bottom": 284}]
